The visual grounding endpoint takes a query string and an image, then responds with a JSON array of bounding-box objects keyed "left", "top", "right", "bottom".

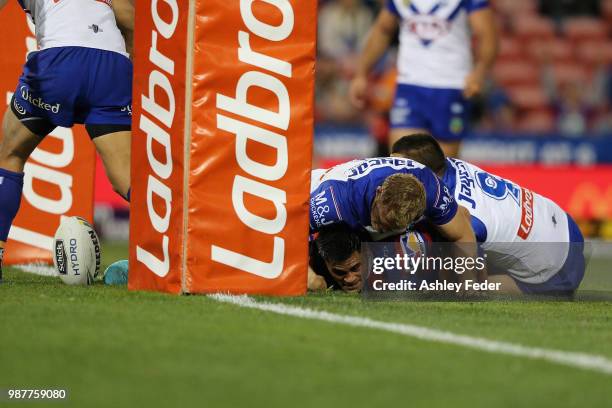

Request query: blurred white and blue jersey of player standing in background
[{"left": 386, "top": 0, "right": 489, "bottom": 89}]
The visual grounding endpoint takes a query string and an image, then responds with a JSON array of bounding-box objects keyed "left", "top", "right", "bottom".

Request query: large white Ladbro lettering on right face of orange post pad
[{"left": 211, "top": 0, "right": 295, "bottom": 279}]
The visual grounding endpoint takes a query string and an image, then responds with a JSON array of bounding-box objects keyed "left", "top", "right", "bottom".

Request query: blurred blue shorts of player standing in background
[{"left": 390, "top": 84, "right": 470, "bottom": 142}]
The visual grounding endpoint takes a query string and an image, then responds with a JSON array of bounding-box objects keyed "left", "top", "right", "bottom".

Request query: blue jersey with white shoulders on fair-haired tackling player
[{"left": 309, "top": 157, "right": 457, "bottom": 231}]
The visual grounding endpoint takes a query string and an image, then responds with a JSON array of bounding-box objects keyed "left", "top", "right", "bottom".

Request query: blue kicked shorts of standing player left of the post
[{"left": 13, "top": 47, "right": 132, "bottom": 127}]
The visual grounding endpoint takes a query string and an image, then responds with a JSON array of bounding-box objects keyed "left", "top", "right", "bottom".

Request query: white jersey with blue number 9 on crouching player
[{"left": 443, "top": 159, "right": 569, "bottom": 283}]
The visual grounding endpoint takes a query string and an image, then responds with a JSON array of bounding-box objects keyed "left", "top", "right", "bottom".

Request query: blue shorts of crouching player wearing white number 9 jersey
[{"left": 515, "top": 214, "right": 586, "bottom": 295}]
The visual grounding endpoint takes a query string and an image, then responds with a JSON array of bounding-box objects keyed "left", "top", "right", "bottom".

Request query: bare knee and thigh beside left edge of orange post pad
[{"left": 86, "top": 125, "right": 132, "bottom": 201}]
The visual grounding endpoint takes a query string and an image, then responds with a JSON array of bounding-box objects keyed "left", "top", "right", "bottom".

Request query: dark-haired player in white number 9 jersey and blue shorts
[{"left": 393, "top": 134, "right": 585, "bottom": 294}]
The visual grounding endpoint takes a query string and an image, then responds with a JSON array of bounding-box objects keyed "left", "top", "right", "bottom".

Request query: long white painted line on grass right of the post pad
[{"left": 209, "top": 294, "right": 612, "bottom": 374}]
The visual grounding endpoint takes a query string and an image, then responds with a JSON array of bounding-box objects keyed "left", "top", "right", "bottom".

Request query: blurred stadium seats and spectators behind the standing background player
[{"left": 316, "top": 0, "right": 612, "bottom": 147}]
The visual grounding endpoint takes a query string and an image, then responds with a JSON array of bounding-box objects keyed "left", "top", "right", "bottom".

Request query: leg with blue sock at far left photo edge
[{"left": 0, "top": 105, "right": 55, "bottom": 281}]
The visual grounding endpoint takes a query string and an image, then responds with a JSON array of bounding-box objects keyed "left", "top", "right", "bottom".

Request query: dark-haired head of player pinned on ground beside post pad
[{"left": 315, "top": 223, "right": 363, "bottom": 292}]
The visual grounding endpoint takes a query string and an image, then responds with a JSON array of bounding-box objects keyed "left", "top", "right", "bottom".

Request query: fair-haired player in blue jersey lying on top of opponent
[{"left": 310, "top": 157, "right": 486, "bottom": 286}]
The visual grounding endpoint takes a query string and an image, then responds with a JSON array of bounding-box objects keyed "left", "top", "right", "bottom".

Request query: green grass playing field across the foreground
[{"left": 0, "top": 241, "right": 612, "bottom": 407}]
